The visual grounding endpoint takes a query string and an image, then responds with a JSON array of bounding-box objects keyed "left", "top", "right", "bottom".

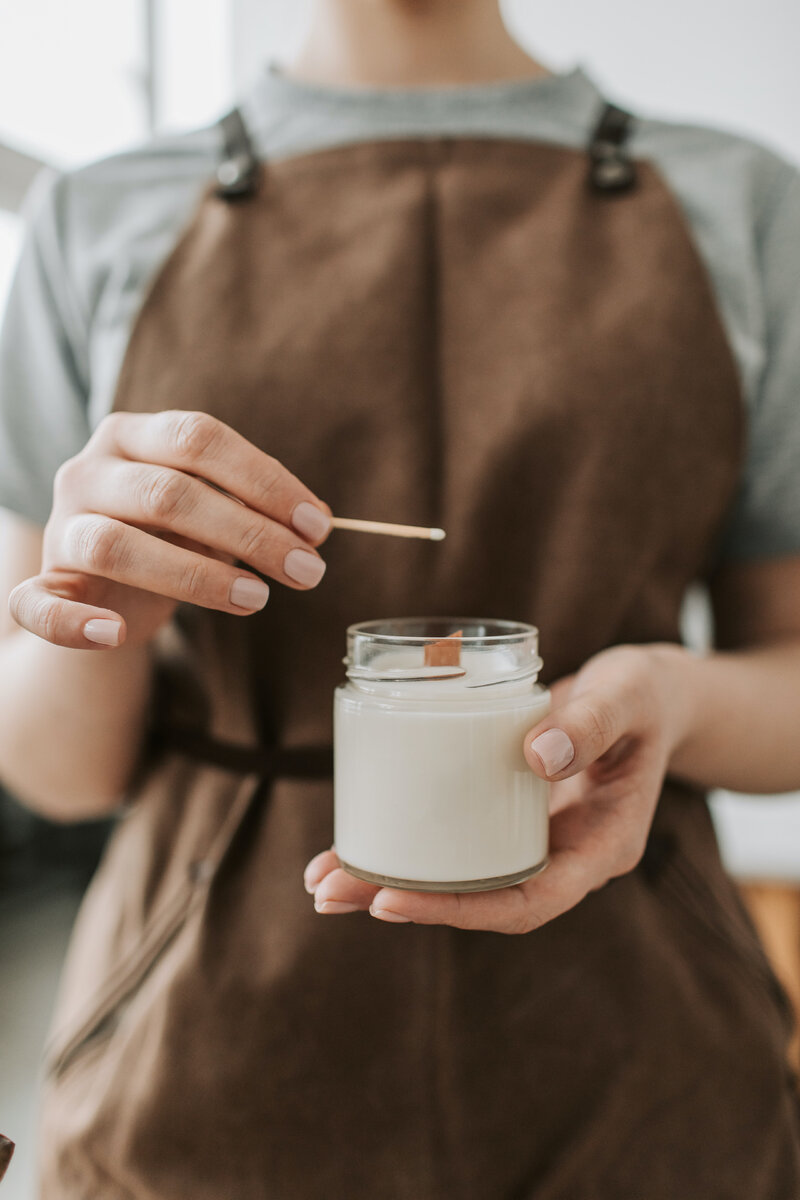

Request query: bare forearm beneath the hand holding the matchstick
[{"left": 0, "top": 630, "right": 152, "bottom": 821}]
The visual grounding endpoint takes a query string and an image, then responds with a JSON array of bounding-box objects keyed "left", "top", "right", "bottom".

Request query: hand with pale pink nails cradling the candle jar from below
[{"left": 306, "top": 646, "right": 686, "bottom": 934}]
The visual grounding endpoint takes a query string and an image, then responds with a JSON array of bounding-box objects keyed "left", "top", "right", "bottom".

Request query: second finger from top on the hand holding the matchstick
[{"left": 84, "top": 460, "right": 325, "bottom": 588}]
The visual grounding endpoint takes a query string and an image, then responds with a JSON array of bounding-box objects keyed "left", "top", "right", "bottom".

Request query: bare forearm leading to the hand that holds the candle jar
[{"left": 651, "top": 637, "right": 800, "bottom": 793}]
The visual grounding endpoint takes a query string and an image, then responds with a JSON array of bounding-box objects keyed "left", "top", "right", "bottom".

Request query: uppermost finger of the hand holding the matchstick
[{"left": 92, "top": 410, "right": 331, "bottom": 545}]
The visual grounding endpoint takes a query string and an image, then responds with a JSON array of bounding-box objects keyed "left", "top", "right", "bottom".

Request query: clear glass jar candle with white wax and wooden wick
[{"left": 333, "top": 617, "right": 549, "bottom": 892}]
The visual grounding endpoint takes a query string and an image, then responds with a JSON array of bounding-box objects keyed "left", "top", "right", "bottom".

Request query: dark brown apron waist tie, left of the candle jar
[{"left": 151, "top": 727, "right": 333, "bottom": 779}]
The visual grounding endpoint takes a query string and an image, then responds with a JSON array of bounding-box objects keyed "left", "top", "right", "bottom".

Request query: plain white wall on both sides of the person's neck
[{"left": 231, "top": 0, "right": 800, "bottom": 162}]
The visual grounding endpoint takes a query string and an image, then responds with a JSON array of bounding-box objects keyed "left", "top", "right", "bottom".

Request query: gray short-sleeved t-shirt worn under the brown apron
[{"left": 0, "top": 68, "right": 800, "bottom": 558}]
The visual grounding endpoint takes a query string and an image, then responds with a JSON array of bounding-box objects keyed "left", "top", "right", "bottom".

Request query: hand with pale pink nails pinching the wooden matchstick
[{"left": 8, "top": 412, "right": 331, "bottom": 649}]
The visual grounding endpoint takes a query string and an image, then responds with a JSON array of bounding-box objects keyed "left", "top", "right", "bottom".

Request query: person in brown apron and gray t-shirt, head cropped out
[{"left": 0, "top": 0, "right": 800, "bottom": 1200}]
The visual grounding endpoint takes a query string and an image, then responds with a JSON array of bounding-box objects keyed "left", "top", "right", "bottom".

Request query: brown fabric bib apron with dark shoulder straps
[{"left": 42, "top": 108, "right": 800, "bottom": 1200}]
